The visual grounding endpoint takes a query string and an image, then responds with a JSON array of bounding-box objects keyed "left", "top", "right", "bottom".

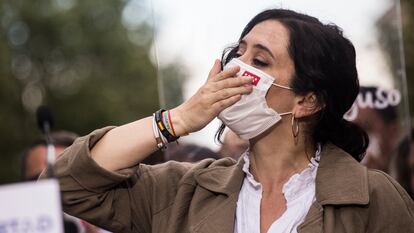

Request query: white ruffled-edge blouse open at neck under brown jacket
[{"left": 234, "top": 146, "right": 320, "bottom": 233}]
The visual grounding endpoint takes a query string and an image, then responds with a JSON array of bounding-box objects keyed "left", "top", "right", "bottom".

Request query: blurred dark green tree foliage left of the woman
[{"left": 0, "top": 0, "right": 182, "bottom": 184}]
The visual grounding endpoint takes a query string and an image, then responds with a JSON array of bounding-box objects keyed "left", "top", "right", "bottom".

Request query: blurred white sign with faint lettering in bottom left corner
[{"left": 0, "top": 180, "right": 63, "bottom": 233}]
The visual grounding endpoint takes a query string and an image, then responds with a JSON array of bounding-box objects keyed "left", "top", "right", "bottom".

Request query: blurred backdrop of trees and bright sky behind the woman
[{"left": 0, "top": 0, "right": 414, "bottom": 199}]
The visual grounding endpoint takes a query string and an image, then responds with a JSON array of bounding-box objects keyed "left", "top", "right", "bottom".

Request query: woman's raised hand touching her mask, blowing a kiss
[{"left": 171, "top": 60, "right": 253, "bottom": 136}]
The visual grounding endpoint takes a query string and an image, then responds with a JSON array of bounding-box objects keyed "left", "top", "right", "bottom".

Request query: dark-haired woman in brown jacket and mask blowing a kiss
[{"left": 45, "top": 9, "right": 414, "bottom": 233}]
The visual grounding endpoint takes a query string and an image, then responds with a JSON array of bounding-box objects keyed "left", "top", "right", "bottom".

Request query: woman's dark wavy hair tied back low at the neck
[{"left": 216, "top": 9, "right": 369, "bottom": 161}]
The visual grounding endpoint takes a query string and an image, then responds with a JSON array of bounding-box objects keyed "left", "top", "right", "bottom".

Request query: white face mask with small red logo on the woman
[{"left": 218, "top": 58, "right": 292, "bottom": 140}]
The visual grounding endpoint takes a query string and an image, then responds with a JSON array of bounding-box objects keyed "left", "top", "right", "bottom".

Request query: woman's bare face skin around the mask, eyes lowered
[{"left": 237, "top": 20, "right": 295, "bottom": 113}]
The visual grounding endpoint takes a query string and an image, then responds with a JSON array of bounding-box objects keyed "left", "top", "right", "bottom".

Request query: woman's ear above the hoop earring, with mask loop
[{"left": 293, "top": 92, "right": 325, "bottom": 118}]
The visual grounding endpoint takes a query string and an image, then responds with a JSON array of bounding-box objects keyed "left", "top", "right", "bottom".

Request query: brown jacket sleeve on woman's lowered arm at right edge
[{"left": 367, "top": 170, "right": 414, "bottom": 233}]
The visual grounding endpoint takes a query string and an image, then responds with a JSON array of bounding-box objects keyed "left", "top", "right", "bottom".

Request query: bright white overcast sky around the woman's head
[{"left": 131, "top": 0, "right": 402, "bottom": 150}]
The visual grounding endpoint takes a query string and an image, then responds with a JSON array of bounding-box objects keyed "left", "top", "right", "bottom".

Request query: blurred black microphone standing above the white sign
[{"left": 36, "top": 106, "right": 56, "bottom": 178}]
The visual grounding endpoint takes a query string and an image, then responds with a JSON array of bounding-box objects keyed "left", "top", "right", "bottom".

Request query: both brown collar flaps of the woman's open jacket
[{"left": 195, "top": 143, "right": 369, "bottom": 205}]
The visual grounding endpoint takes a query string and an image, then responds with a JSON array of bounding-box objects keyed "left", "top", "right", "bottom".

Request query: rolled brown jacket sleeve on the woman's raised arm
[{"left": 42, "top": 127, "right": 159, "bottom": 232}]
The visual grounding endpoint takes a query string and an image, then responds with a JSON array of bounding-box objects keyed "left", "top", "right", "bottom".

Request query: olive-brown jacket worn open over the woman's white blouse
[{"left": 48, "top": 128, "right": 414, "bottom": 233}]
